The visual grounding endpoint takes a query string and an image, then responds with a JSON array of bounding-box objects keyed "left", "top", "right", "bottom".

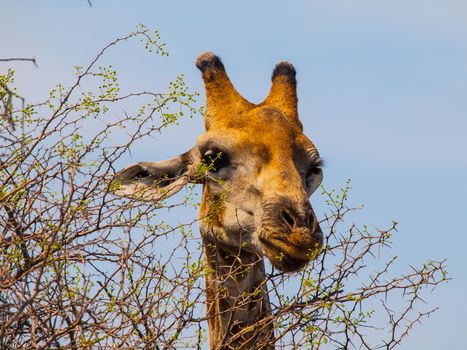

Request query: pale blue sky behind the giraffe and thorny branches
[{"left": 0, "top": 0, "right": 467, "bottom": 350}]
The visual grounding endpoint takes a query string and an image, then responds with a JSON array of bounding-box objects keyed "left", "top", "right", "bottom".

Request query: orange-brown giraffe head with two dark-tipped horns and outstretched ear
[{"left": 115, "top": 53, "right": 323, "bottom": 271}]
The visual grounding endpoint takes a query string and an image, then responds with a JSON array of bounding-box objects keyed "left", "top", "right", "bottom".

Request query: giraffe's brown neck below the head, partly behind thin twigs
[{"left": 204, "top": 242, "right": 274, "bottom": 350}]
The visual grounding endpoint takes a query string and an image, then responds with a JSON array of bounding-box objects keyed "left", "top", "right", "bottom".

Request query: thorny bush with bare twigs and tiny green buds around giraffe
[{"left": 0, "top": 26, "right": 447, "bottom": 349}]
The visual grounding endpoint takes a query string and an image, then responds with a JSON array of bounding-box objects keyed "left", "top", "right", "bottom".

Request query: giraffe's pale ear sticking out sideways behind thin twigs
[{"left": 110, "top": 147, "right": 203, "bottom": 202}]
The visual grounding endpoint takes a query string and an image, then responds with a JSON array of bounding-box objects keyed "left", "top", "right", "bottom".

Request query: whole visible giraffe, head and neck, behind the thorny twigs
[{"left": 114, "top": 52, "right": 323, "bottom": 349}]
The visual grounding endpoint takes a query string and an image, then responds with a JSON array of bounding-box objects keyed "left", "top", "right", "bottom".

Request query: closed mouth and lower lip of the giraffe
[{"left": 259, "top": 237, "right": 311, "bottom": 272}]
